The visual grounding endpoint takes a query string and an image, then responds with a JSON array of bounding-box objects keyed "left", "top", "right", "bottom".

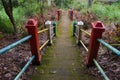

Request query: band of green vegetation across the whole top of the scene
[{"left": 0, "top": 0, "right": 120, "bottom": 32}]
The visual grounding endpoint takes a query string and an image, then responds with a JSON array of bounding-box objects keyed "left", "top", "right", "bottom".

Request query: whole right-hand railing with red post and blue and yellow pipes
[{"left": 73, "top": 21, "right": 120, "bottom": 80}]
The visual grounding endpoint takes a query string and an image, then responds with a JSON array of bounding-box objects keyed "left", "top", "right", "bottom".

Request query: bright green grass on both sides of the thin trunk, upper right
[{"left": 73, "top": 2, "right": 120, "bottom": 22}]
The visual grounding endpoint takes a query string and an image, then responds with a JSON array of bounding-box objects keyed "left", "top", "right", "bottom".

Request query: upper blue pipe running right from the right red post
[{"left": 98, "top": 39, "right": 120, "bottom": 56}]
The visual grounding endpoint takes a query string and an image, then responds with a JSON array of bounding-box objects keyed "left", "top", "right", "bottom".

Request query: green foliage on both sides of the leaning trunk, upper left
[{"left": 0, "top": 0, "right": 48, "bottom": 32}]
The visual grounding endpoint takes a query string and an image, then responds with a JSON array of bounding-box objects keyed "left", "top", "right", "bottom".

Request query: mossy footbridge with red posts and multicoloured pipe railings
[{"left": 0, "top": 11, "right": 120, "bottom": 80}]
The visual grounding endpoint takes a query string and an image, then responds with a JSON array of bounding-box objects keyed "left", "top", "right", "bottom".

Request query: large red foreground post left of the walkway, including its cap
[{"left": 26, "top": 19, "right": 42, "bottom": 65}]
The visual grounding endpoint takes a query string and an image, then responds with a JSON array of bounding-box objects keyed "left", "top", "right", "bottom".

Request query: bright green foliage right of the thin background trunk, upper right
[{"left": 90, "top": 3, "right": 120, "bottom": 22}]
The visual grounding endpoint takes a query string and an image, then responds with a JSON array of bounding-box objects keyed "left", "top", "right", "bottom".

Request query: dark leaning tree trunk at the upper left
[{"left": 1, "top": 0, "right": 17, "bottom": 33}]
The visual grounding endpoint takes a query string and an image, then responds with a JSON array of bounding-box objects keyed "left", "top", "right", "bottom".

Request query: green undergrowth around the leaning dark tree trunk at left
[{"left": 0, "top": 1, "right": 49, "bottom": 33}]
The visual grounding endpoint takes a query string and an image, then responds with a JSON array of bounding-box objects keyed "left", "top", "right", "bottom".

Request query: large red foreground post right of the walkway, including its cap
[{"left": 86, "top": 21, "right": 105, "bottom": 66}]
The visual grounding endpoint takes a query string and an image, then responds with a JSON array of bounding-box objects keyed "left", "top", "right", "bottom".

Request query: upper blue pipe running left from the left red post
[{"left": 0, "top": 35, "right": 32, "bottom": 55}]
